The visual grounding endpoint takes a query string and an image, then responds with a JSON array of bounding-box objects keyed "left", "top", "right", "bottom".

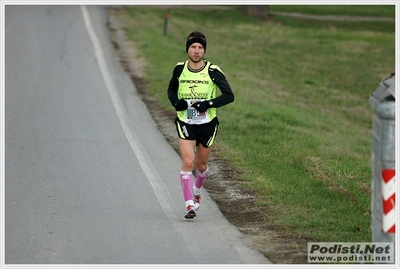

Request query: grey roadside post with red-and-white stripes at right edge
[{"left": 369, "top": 74, "right": 396, "bottom": 262}]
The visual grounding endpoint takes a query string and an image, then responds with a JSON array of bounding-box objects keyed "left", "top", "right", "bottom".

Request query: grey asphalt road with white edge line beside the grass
[{"left": 3, "top": 5, "right": 270, "bottom": 268}]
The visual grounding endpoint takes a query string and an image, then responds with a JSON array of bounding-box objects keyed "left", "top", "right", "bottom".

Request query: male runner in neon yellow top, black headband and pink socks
[{"left": 168, "top": 31, "right": 234, "bottom": 219}]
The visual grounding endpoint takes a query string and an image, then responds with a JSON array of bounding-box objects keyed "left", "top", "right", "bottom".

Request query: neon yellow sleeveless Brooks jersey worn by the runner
[{"left": 177, "top": 61, "right": 218, "bottom": 124}]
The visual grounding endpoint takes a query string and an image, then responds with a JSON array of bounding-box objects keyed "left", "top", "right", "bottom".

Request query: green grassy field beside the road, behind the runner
[{"left": 115, "top": 5, "right": 395, "bottom": 242}]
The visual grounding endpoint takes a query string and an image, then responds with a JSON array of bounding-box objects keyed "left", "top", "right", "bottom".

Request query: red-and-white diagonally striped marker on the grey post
[{"left": 382, "top": 169, "right": 396, "bottom": 233}]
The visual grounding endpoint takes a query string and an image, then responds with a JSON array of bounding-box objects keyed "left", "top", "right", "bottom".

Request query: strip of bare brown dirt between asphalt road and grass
[{"left": 108, "top": 7, "right": 312, "bottom": 264}]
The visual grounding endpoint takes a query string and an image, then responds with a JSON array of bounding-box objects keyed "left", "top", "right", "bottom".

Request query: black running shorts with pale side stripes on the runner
[{"left": 175, "top": 117, "right": 219, "bottom": 148}]
